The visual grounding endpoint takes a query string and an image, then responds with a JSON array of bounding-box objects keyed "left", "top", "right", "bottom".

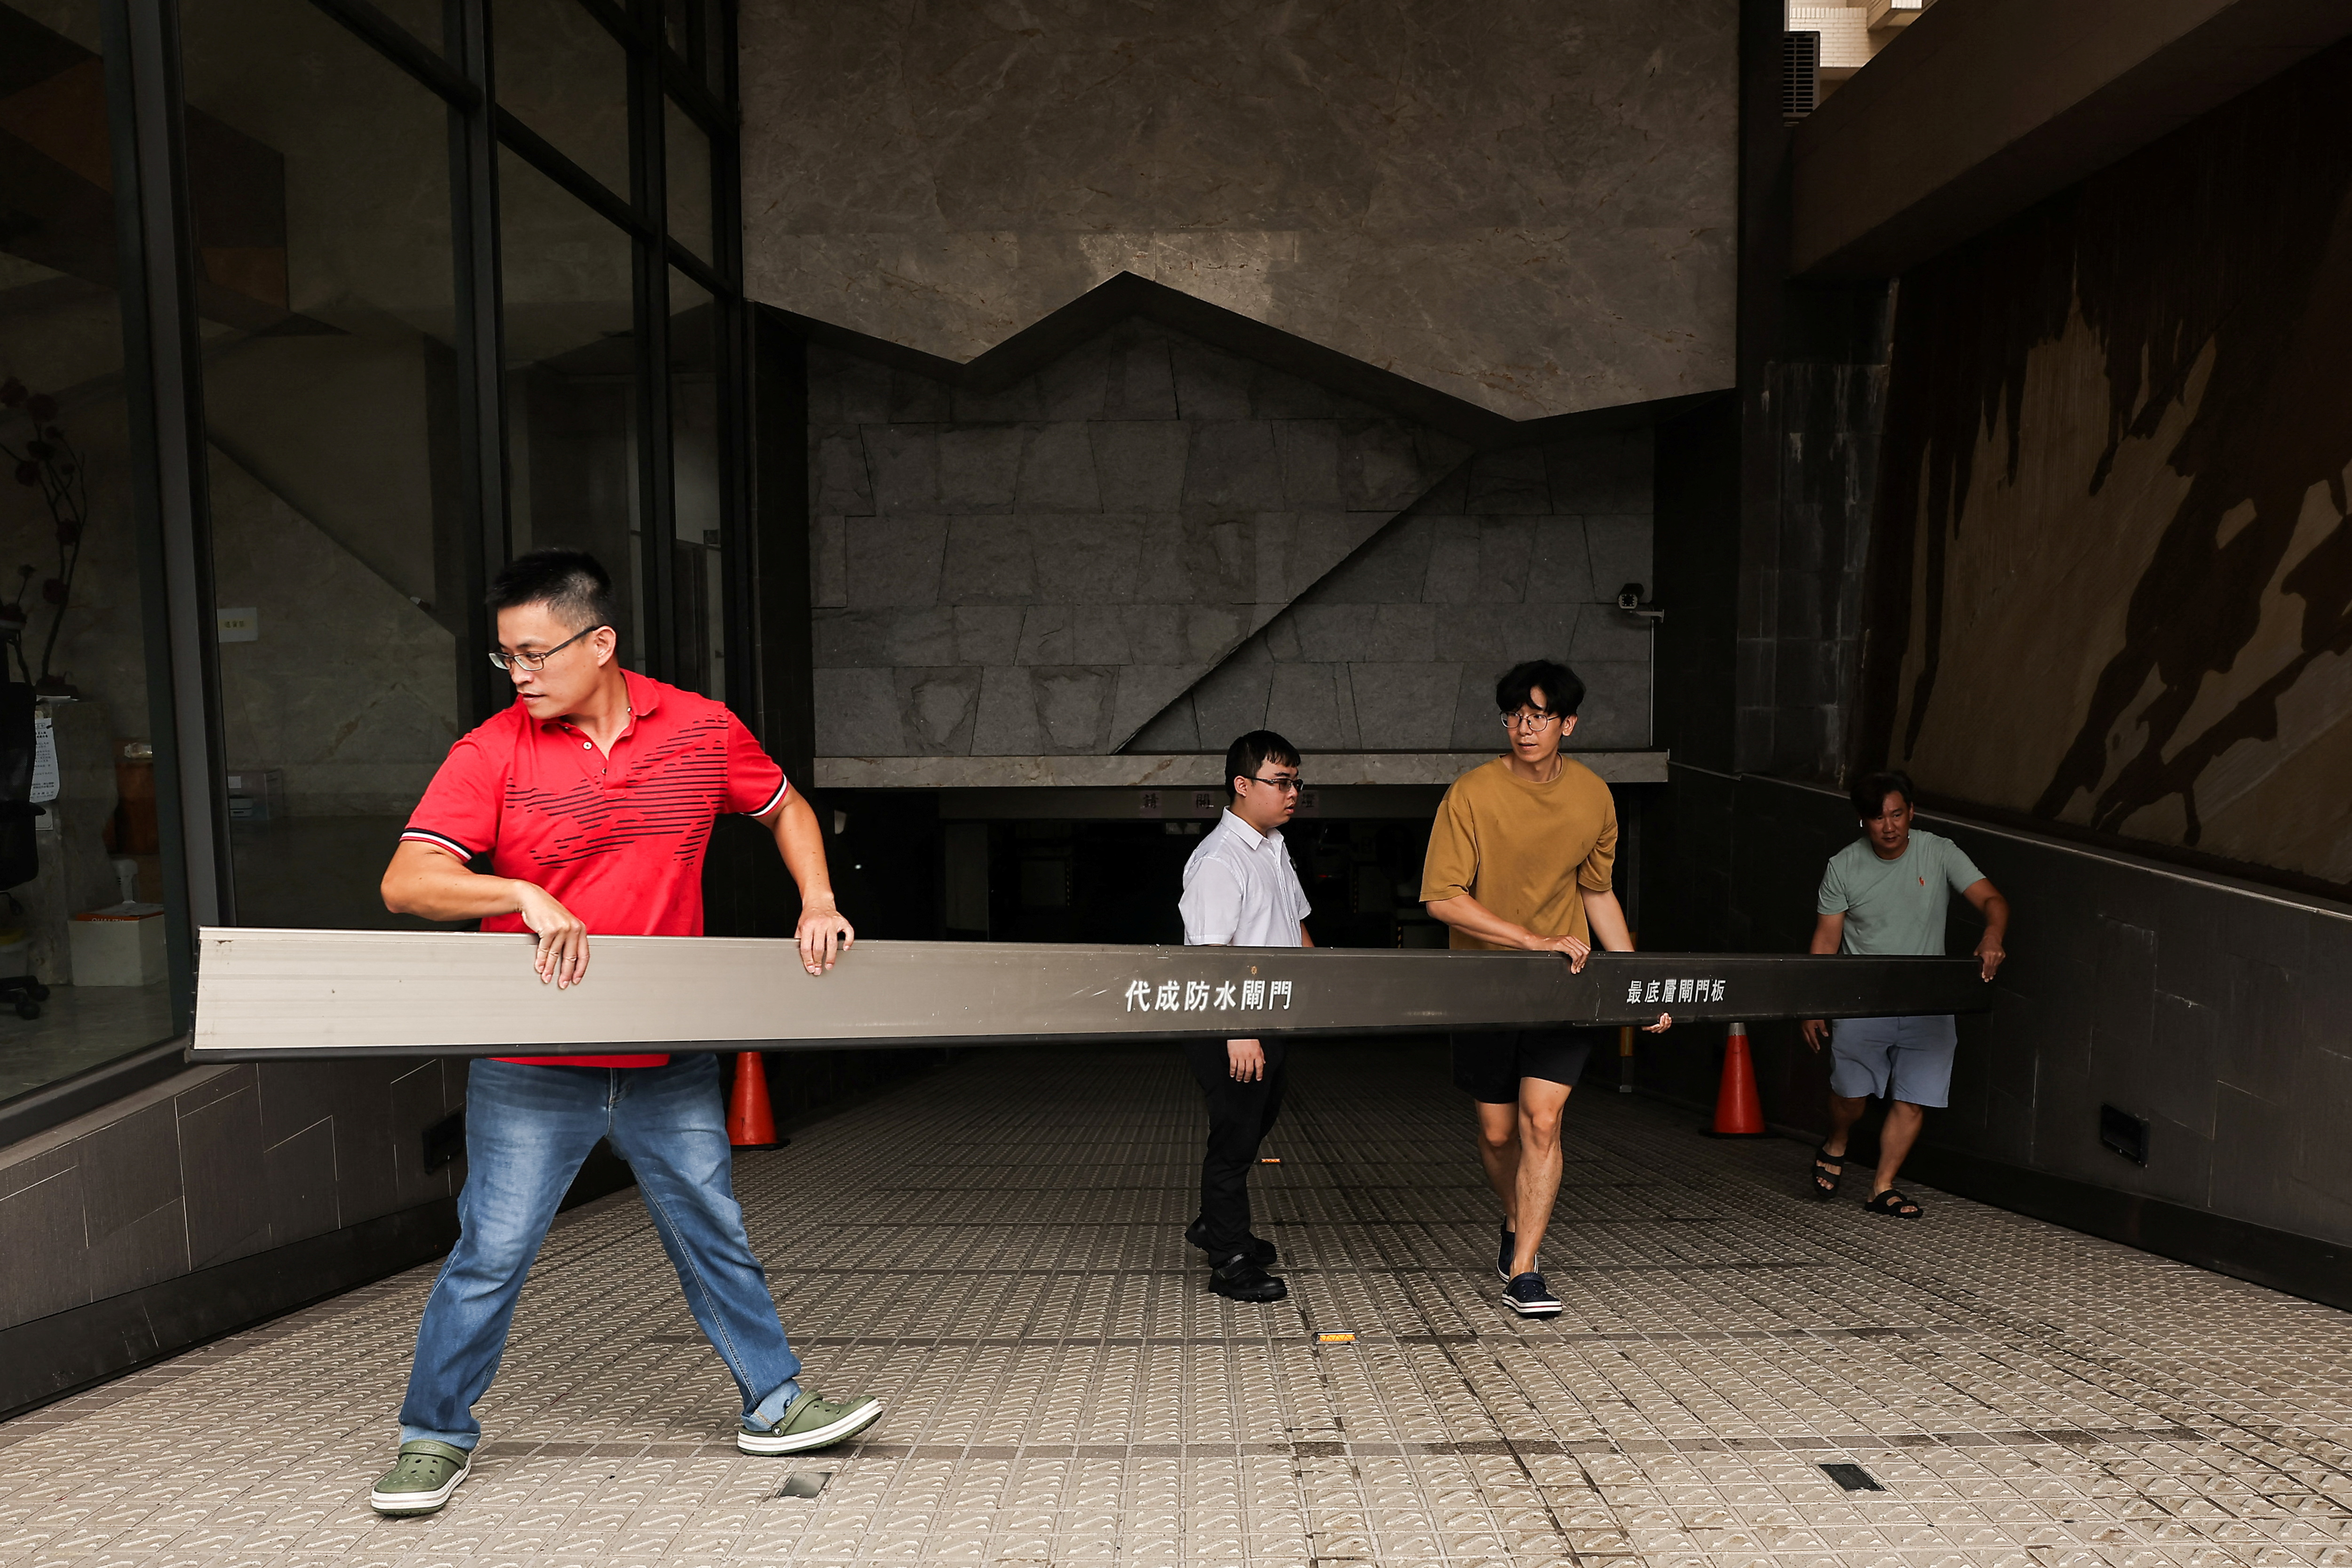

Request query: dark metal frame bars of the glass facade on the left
[{"left": 0, "top": 0, "right": 748, "bottom": 1140}]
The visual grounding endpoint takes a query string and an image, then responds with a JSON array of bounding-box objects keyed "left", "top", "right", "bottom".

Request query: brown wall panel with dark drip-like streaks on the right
[{"left": 1856, "top": 45, "right": 2352, "bottom": 886}]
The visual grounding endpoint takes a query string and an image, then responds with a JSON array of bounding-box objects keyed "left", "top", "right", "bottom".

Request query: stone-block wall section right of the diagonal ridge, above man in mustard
[{"left": 1136, "top": 430, "right": 1653, "bottom": 752}]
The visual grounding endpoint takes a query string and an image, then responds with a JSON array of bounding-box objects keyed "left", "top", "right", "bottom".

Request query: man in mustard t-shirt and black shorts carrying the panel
[{"left": 1421, "top": 658, "right": 1672, "bottom": 1316}]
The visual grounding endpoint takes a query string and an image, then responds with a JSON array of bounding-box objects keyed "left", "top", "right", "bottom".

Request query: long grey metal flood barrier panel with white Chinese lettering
[{"left": 193, "top": 926, "right": 1992, "bottom": 1060}]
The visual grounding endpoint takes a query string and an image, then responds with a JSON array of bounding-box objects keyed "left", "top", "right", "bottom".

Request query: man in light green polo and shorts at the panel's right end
[{"left": 1804, "top": 773, "right": 2009, "bottom": 1220}]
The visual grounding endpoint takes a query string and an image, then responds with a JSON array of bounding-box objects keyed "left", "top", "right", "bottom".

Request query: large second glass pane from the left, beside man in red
[{"left": 181, "top": 0, "right": 466, "bottom": 926}]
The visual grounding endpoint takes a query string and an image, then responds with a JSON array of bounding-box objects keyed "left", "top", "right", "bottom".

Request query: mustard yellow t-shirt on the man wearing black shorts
[{"left": 1421, "top": 757, "right": 1616, "bottom": 947}]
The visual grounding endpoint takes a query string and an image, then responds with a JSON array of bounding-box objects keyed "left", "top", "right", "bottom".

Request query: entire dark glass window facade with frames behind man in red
[{"left": 0, "top": 0, "right": 753, "bottom": 1105}]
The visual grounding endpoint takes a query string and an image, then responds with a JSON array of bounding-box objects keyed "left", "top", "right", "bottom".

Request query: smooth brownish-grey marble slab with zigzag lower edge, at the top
[{"left": 741, "top": 0, "right": 1738, "bottom": 418}]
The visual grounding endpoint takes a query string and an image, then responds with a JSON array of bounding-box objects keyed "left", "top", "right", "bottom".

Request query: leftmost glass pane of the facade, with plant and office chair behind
[{"left": 0, "top": 0, "right": 172, "bottom": 1100}]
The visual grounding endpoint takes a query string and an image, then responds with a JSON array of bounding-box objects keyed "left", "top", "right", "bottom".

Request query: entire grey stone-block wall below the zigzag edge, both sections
[{"left": 811, "top": 322, "right": 1651, "bottom": 757}]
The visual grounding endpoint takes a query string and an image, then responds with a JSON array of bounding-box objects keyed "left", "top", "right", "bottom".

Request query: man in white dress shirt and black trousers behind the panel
[{"left": 1178, "top": 729, "right": 1315, "bottom": 1302}]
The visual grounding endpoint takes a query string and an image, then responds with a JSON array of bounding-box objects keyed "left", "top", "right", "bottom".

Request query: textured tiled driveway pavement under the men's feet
[{"left": 0, "top": 1046, "right": 2352, "bottom": 1568}]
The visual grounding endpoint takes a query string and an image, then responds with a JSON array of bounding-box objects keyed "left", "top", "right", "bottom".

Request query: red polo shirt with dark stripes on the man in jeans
[{"left": 400, "top": 670, "right": 793, "bottom": 1067}]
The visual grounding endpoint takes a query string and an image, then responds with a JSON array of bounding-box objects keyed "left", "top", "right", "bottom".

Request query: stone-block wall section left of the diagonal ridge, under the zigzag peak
[{"left": 809, "top": 322, "right": 1468, "bottom": 757}]
